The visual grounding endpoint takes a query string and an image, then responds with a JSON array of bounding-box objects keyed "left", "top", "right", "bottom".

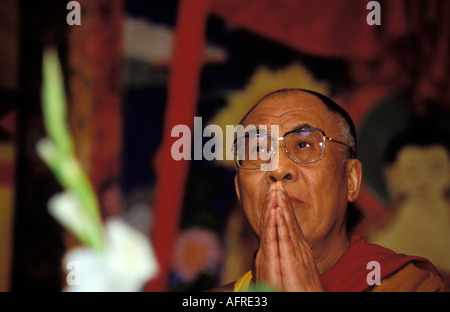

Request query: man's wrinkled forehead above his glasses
[{"left": 244, "top": 92, "right": 338, "bottom": 136}]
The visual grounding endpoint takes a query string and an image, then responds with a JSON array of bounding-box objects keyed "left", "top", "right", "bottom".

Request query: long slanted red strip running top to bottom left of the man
[{"left": 146, "top": 0, "right": 210, "bottom": 291}]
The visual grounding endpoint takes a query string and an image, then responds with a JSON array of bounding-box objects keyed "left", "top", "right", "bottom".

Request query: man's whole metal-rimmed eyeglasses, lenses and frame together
[{"left": 233, "top": 127, "right": 355, "bottom": 170}]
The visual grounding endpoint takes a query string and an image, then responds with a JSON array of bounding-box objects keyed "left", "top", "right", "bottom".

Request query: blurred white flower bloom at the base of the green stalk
[{"left": 63, "top": 218, "right": 158, "bottom": 292}]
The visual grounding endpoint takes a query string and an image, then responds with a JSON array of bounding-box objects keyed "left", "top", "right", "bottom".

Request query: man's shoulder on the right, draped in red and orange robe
[{"left": 321, "top": 236, "right": 449, "bottom": 292}]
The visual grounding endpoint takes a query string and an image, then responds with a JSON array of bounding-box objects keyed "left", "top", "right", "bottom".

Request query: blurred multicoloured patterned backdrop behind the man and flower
[{"left": 0, "top": 0, "right": 450, "bottom": 291}]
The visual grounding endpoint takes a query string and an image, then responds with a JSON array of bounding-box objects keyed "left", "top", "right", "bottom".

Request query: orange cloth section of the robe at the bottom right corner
[{"left": 372, "top": 263, "right": 450, "bottom": 292}]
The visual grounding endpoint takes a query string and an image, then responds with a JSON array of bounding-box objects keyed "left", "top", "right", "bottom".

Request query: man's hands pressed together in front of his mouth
[{"left": 255, "top": 181, "right": 323, "bottom": 291}]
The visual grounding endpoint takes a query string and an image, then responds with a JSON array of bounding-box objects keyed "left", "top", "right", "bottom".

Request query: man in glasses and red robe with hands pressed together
[{"left": 217, "top": 89, "right": 446, "bottom": 291}]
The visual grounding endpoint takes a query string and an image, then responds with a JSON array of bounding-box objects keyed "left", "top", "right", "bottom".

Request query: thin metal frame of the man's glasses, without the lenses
[{"left": 232, "top": 127, "right": 355, "bottom": 170}]
